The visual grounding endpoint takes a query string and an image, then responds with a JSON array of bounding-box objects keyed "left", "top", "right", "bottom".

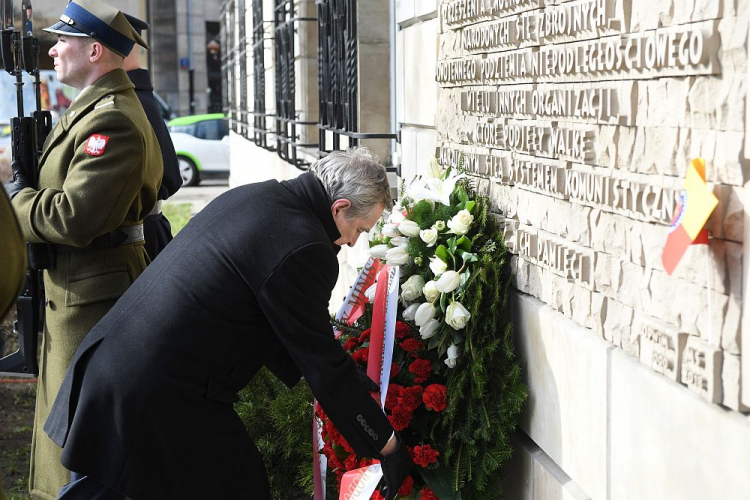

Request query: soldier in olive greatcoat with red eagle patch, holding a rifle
[{"left": 6, "top": 0, "right": 162, "bottom": 498}]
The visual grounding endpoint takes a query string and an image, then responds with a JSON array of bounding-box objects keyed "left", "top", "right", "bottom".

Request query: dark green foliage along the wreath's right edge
[{"left": 443, "top": 193, "right": 528, "bottom": 500}]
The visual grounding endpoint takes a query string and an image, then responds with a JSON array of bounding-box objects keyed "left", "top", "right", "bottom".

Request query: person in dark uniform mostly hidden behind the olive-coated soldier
[{"left": 122, "top": 14, "right": 182, "bottom": 260}]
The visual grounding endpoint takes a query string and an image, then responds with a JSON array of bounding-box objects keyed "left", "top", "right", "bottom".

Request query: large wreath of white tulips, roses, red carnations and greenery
[{"left": 316, "top": 158, "right": 527, "bottom": 500}]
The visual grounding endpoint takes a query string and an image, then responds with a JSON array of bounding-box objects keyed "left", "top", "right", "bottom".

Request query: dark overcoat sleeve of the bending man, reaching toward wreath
[{"left": 258, "top": 243, "right": 393, "bottom": 457}]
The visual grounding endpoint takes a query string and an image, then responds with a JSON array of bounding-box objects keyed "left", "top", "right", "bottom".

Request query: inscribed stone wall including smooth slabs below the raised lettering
[{"left": 434, "top": 0, "right": 750, "bottom": 499}]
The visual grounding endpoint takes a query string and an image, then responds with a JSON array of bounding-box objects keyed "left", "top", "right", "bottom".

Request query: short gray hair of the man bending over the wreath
[{"left": 310, "top": 146, "right": 393, "bottom": 219}]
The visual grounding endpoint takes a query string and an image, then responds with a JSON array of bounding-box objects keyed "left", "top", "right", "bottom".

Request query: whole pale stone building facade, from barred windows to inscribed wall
[{"left": 222, "top": 0, "right": 750, "bottom": 500}]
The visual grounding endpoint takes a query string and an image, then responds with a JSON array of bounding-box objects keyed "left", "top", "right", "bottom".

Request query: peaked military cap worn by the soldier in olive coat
[{"left": 44, "top": 0, "right": 148, "bottom": 57}]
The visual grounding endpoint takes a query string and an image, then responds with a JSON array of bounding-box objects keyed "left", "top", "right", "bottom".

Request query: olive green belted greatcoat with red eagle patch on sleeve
[{"left": 13, "top": 69, "right": 163, "bottom": 499}]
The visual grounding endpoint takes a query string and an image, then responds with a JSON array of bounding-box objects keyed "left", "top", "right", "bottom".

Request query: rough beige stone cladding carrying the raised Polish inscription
[{"left": 435, "top": 0, "right": 750, "bottom": 418}]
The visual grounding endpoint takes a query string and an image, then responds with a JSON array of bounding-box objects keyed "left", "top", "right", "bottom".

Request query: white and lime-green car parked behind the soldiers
[{"left": 167, "top": 113, "right": 229, "bottom": 186}]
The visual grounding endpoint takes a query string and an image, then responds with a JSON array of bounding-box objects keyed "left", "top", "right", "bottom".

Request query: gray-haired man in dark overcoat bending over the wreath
[{"left": 45, "top": 148, "right": 411, "bottom": 500}]
